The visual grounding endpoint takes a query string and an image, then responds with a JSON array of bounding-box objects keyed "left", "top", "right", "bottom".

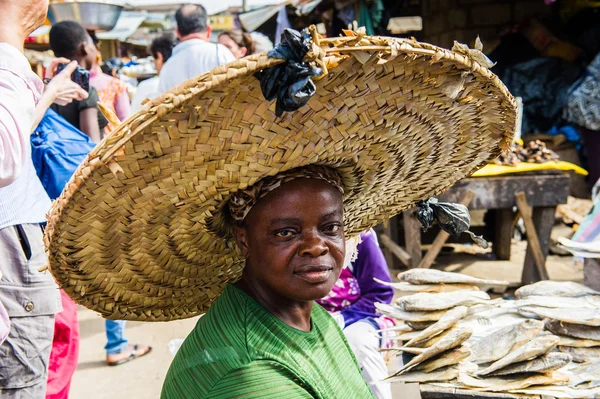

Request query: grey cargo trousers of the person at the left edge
[{"left": 0, "top": 224, "right": 62, "bottom": 399}]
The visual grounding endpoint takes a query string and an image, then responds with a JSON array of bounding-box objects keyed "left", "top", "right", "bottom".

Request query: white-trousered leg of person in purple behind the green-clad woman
[{"left": 344, "top": 321, "right": 392, "bottom": 399}]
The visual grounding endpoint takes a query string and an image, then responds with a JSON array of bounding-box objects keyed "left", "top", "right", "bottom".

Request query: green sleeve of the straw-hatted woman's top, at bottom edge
[{"left": 207, "top": 360, "right": 313, "bottom": 399}]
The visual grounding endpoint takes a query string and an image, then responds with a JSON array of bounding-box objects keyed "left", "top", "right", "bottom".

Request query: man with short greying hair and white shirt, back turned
[{"left": 159, "top": 5, "right": 235, "bottom": 94}]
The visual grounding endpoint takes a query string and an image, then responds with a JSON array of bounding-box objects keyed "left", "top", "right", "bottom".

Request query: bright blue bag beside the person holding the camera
[{"left": 31, "top": 109, "right": 96, "bottom": 200}]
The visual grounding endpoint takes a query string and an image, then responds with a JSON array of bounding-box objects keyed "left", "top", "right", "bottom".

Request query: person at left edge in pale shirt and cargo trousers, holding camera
[{"left": 0, "top": 0, "right": 87, "bottom": 399}]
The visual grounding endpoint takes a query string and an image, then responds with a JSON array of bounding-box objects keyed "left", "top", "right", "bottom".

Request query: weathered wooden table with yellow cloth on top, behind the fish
[{"left": 382, "top": 171, "right": 569, "bottom": 284}]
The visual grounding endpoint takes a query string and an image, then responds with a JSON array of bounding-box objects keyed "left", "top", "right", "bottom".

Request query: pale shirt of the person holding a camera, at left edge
[{"left": 0, "top": 43, "right": 50, "bottom": 229}]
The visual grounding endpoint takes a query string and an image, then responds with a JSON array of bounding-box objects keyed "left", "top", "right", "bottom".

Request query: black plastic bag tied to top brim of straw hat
[{"left": 255, "top": 29, "right": 323, "bottom": 116}]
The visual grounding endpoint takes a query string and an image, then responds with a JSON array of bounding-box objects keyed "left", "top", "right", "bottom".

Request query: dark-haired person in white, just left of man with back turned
[{"left": 131, "top": 33, "right": 177, "bottom": 113}]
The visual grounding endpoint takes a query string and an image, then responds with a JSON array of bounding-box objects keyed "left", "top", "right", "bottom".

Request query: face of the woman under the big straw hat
[{"left": 236, "top": 179, "right": 345, "bottom": 301}]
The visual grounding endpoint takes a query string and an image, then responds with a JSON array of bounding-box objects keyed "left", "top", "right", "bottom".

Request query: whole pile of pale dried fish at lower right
[{"left": 377, "top": 269, "right": 600, "bottom": 398}]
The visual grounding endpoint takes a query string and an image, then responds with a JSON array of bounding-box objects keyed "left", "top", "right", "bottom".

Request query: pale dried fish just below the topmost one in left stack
[{"left": 396, "top": 291, "right": 490, "bottom": 312}]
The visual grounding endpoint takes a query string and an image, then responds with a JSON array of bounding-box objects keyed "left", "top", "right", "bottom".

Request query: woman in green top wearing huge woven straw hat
[{"left": 46, "top": 30, "right": 516, "bottom": 399}]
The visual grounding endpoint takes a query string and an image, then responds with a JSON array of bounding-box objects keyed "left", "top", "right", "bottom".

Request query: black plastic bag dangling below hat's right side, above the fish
[{"left": 415, "top": 198, "right": 488, "bottom": 248}]
